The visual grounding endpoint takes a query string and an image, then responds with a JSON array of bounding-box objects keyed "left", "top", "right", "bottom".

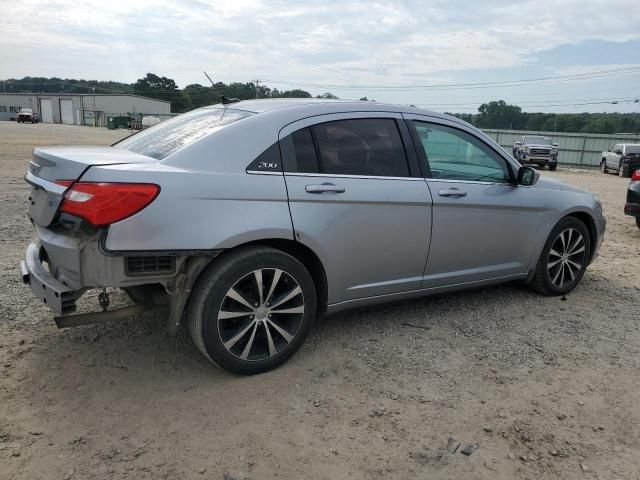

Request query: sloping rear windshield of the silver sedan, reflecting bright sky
[{"left": 113, "top": 108, "right": 254, "bottom": 160}]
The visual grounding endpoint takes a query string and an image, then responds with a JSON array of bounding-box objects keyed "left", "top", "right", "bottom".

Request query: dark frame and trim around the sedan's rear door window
[{"left": 278, "top": 115, "right": 416, "bottom": 180}]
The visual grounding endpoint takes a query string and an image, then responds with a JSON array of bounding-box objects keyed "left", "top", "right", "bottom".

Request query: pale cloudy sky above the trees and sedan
[{"left": 0, "top": 0, "right": 640, "bottom": 113}]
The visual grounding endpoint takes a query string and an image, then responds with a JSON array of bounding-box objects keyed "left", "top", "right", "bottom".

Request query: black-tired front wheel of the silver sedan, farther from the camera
[{"left": 529, "top": 217, "right": 591, "bottom": 295}]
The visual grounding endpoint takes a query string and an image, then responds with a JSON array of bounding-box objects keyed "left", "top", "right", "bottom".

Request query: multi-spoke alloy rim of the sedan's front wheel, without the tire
[{"left": 547, "top": 228, "right": 586, "bottom": 288}]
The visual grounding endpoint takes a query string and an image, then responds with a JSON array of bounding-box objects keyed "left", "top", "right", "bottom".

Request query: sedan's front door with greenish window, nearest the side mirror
[{"left": 405, "top": 115, "right": 542, "bottom": 288}]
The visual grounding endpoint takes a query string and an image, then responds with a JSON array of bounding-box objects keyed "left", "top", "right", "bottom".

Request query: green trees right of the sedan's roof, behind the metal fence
[{"left": 452, "top": 100, "right": 640, "bottom": 134}]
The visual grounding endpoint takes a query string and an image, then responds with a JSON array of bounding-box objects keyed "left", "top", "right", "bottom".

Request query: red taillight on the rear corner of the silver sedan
[{"left": 56, "top": 181, "right": 160, "bottom": 227}]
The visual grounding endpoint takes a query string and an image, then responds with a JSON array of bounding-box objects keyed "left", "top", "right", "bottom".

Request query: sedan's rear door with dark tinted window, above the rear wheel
[{"left": 280, "top": 112, "right": 431, "bottom": 304}]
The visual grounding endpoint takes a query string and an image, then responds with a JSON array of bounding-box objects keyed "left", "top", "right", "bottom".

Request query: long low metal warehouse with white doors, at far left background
[{"left": 0, "top": 93, "right": 171, "bottom": 127}]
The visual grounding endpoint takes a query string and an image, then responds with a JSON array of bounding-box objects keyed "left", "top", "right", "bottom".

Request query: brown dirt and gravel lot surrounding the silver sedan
[{"left": 0, "top": 122, "right": 640, "bottom": 480}]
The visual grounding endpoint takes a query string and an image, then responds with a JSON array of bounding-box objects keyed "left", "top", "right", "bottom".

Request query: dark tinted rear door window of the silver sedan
[{"left": 282, "top": 118, "right": 410, "bottom": 177}]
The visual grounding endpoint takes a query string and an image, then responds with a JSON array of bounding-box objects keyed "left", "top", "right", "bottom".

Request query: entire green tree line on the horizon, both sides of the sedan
[{"left": 0, "top": 73, "right": 640, "bottom": 134}]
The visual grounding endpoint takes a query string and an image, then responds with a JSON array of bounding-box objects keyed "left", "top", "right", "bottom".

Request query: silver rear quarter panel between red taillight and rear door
[{"left": 83, "top": 164, "right": 293, "bottom": 251}]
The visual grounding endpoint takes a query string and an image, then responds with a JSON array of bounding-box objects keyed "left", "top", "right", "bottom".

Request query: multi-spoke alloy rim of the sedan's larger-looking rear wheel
[{"left": 217, "top": 268, "right": 305, "bottom": 361}]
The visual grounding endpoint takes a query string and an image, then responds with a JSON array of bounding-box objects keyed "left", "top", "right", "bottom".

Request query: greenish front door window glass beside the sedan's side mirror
[{"left": 413, "top": 121, "right": 511, "bottom": 183}]
